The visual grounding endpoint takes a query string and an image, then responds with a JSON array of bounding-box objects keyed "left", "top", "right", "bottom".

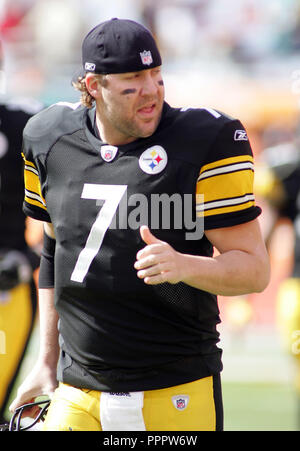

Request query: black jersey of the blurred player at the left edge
[{"left": 0, "top": 99, "right": 41, "bottom": 250}]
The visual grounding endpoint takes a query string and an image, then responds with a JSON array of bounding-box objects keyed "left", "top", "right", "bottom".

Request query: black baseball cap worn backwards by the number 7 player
[{"left": 82, "top": 18, "right": 162, "bottom": 74}]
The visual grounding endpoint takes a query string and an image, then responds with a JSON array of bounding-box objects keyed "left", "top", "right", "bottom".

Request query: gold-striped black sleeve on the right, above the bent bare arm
[{"left": 196, "top": 120, "right": 261, "bottom": 230}]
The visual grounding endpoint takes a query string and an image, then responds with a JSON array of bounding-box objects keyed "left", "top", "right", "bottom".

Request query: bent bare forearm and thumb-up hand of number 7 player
[{"left": 134, "top": 221, "right": 270, "bottom": 296}]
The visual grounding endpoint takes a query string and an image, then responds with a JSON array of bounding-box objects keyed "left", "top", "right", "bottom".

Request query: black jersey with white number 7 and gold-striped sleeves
[{"left": 23, "top": 103, "right": 260, "bottom": 391}]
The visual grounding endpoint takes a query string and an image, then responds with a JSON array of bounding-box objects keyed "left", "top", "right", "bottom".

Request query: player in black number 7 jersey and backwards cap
[{"left": 11, "top": 19, "right": 269, "bottom": 431}]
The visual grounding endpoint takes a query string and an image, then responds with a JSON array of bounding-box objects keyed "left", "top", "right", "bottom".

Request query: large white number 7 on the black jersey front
[{"left": 71, "top": 183, "right": 127, "bottom": 283}]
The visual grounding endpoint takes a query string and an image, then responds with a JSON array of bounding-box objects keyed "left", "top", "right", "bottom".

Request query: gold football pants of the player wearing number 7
[{"left": 43, "top": 376, "right": 223, "bottom": 431}]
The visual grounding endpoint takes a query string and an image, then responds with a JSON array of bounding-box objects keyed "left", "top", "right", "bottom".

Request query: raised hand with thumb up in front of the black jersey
[{"left": 134, "top": 226, "right": 184, "bottom": 285}]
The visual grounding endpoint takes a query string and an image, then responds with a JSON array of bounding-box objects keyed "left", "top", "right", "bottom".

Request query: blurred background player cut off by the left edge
[{"left": 0, "top": 86, "right": 41, "bottom": 422}]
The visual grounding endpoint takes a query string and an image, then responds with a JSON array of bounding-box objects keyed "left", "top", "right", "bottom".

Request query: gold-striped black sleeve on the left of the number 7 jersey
[{"left": 22, "top": 151, "right": 51, "bottom": 222}]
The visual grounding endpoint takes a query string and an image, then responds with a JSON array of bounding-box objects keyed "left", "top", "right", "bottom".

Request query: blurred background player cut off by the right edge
[{"left": 257, "top": 139, "right": 300, "bottom": 425}]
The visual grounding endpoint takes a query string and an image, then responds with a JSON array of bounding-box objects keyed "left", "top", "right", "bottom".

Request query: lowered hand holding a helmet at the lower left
[{"left": 9, "top": 363, "right": 57, "bottom": 418}]
